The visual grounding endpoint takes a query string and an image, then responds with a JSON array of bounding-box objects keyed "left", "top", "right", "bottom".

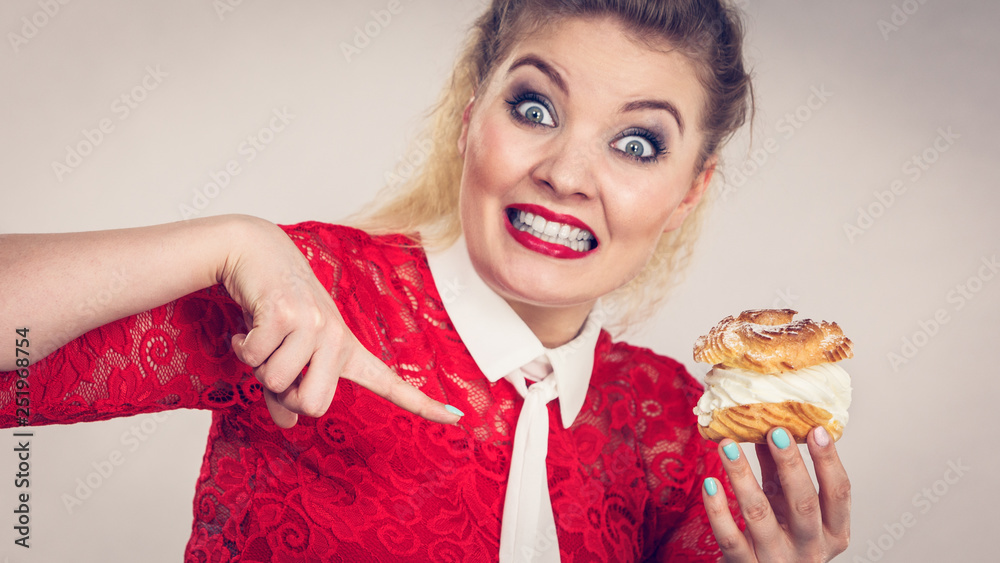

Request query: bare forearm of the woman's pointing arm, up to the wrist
[{"left": 0, "top": 216, "right": 254, "bottom": 371}]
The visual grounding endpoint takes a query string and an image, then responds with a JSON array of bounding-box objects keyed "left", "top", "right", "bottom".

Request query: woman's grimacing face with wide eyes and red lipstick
[{"left": 459, "top": 18, "right": 712, "bottom": 330}]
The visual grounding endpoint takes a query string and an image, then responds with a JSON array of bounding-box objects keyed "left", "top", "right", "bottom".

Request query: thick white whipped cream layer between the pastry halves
[{"left": 694, "top": 363, "right": 851, "bottom": 426}]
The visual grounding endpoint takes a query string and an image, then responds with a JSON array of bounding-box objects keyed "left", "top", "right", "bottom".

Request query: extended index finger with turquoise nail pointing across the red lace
[{"left": 340, "top": 343, "right": 462, "bottom": 424}]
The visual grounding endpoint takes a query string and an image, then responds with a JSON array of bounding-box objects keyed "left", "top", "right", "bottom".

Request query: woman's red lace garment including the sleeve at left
[{"left": 0, "top": 223, "right": 735, "bottom": 563}]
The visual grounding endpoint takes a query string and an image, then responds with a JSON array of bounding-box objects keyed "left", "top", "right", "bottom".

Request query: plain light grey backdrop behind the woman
[{"left": 0, "top": 0, "right": 1000, "bottom": 563}]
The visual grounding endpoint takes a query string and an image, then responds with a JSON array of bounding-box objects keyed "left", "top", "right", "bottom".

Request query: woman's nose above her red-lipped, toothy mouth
[{"left": 531, "top": 132, "right": 602, "bottom": 199}]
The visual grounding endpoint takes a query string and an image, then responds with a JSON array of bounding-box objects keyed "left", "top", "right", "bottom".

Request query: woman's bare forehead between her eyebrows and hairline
[{"left": 494, "top": 17, "right": 705, "bottom": 131}]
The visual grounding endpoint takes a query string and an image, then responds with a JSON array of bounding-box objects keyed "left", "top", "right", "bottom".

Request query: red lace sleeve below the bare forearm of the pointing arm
[{"left": 0, "top": 286, "right": 260, "bottom": 427}]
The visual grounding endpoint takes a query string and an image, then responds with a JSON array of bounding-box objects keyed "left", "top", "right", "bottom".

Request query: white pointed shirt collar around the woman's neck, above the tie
[{"left": 427, "top": 237, "right": 604, "bottom": 428}]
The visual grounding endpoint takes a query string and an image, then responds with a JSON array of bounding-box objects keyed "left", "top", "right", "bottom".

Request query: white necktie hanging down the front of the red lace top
[{"left": 500, "top": 356, "right": 559, "bottom": 563}]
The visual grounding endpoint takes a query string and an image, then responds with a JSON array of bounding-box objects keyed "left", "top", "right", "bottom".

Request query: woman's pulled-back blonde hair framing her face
[{"left": 350, "top": 0, "right": 753, "bottom": 328}]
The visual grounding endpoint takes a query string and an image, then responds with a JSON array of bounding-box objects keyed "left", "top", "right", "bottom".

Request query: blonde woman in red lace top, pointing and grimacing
[{"left": 0, "top": 0, "right": 849, "bottom": 561}]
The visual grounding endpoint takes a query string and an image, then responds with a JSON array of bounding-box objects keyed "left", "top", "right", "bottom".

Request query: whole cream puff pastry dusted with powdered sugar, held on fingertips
[{"left": 694, "top": 309, "right": 854, "bottom": 444}]
